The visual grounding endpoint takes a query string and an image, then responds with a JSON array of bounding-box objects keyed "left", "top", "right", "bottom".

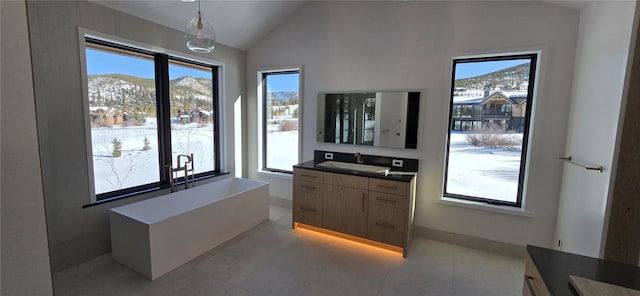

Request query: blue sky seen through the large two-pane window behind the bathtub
[{"left": 86, "top": 48, "right": 211, "bottom": 79}]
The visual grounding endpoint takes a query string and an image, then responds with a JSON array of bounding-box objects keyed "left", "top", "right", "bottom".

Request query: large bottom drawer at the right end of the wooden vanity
[{"left": 367, "top": 205, "right": 407, "bottom": 247}]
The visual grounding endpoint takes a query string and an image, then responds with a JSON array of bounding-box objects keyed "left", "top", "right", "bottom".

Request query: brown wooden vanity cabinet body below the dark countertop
[{"left": 293, "top": 168, "right": 415, "bottom": 257}]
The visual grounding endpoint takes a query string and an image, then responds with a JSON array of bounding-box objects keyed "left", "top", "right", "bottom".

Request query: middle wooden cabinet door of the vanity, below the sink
[{"left": 322, "top": 184, "right": 369, "bottom": 238}]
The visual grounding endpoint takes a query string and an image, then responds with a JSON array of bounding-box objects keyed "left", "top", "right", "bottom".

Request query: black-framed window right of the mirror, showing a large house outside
[{"left": 444, "top": 54, "right": 537, "bottom": 207}]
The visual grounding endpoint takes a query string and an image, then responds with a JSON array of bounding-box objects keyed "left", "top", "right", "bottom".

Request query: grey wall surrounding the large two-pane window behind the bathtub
[{"left": 25, "top": 1, "right": 245, "bottom": 271}]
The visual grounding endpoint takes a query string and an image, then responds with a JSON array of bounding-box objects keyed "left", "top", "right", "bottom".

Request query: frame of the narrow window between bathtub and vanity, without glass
[{"left": 258, "top": 67, "right": 302, "bottom": 175}]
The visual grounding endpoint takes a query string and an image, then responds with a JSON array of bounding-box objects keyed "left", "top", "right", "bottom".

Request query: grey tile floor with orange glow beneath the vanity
[{"left": 53, "top": 206, "right": 524, "bottom": 296}]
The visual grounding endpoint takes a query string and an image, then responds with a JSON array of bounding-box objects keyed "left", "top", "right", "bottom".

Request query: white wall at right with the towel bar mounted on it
[{"left": 556, "top": 1, "right": 635, "bottom": 257}]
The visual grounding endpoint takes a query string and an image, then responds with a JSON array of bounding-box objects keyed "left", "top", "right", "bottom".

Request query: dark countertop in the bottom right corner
[{"left": 527, "top": 246, "right": 640, "bottom": 296}]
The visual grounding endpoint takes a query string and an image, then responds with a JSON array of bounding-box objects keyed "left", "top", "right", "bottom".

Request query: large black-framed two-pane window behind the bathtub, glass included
[{"left": 85, "top": 37, "right": 220, "bottom": 201}]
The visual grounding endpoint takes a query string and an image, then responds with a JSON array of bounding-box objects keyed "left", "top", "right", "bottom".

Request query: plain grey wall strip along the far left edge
[{"left": 0, "top": 1, "right": 53, "bottom": 296}]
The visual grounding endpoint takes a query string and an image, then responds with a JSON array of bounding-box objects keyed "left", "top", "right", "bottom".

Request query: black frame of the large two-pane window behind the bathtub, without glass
[{"left": 81, "top": 37, "right": 224, "bottom": 207}]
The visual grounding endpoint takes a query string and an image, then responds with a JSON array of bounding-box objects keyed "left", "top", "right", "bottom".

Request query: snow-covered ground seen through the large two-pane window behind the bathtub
[{"left": 91, "top": 118, "right": 214, "bottom": 194}]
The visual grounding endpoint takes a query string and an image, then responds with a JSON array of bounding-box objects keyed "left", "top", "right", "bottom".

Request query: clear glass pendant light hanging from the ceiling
[{"left": 184, "top": 0, "right": 216, "bottom": 53}]
